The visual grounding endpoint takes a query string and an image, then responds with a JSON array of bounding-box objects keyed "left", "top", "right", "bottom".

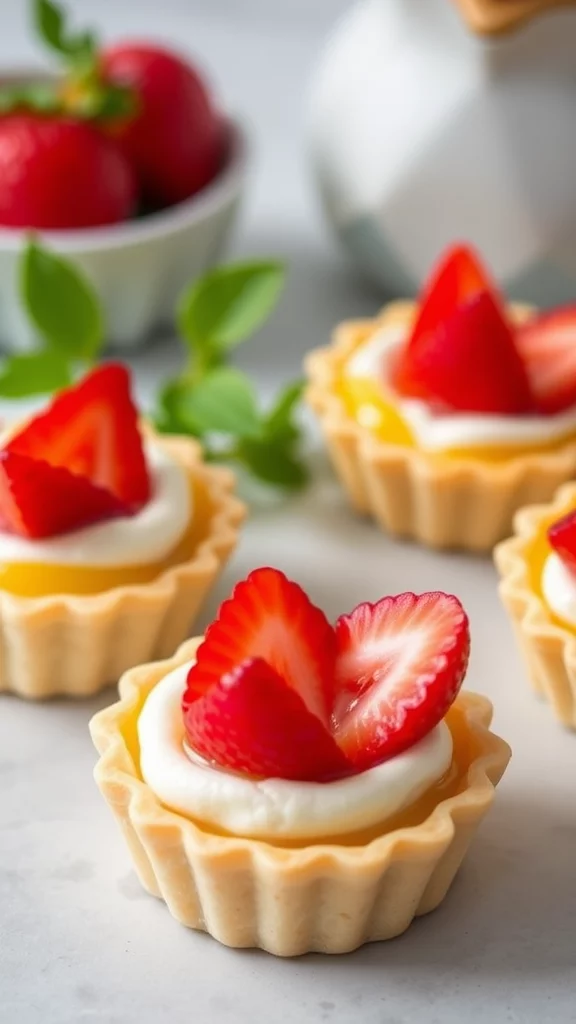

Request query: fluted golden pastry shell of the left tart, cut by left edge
[{"left": 0, "top": 430, "right": 245, "bottom": 699}]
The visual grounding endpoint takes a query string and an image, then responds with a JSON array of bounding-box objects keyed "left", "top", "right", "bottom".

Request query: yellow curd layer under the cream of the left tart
[{"left": 0, "top": 477, "right": 213, "bottom": 597}]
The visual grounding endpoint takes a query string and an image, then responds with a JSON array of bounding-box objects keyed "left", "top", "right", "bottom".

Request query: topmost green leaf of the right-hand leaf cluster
[{"left": 177, "top": 260, "right": 284, "bottom": 351}]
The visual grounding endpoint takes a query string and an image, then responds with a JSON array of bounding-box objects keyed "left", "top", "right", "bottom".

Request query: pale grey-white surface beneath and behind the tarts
[{"left": 0, "top": 0, "right": 576, "bottom": 1024}]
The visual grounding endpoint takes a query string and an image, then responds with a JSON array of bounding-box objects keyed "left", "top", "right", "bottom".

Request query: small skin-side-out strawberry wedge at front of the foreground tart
[{"left": 184, "top": 657, "right": 352, "bottom": 781}]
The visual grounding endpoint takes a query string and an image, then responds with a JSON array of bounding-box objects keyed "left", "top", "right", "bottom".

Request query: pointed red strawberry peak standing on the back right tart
[{"left": 393, "top": 241, "right": 534, "bottom": 416}]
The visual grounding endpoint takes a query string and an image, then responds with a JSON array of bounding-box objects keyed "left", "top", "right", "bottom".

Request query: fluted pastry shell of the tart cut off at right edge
[{"left": 494, "top": 483, "right": 576, "bottom": 729}]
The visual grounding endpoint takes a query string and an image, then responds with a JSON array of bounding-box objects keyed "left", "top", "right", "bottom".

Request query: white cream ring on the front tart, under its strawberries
[{"left": 138, "top": 663, "right": 453, "bottom": 840}]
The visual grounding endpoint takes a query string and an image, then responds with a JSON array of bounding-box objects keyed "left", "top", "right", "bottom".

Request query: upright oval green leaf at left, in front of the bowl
[{"left": 19, "top": 241, "right": 105, "bottom": 360}]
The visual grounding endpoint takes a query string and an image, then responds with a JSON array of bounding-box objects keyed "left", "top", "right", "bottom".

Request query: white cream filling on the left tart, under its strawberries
[{"left": 0, "top": 444, "right": 193, "bottom": 568}]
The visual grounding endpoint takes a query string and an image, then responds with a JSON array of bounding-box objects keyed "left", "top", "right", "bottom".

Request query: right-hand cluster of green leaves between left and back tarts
[{"left": 155, "top": 260, "right": 306, "bottom": 488}]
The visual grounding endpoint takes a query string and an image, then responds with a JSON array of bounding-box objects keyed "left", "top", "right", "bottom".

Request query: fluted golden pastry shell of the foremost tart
[{"left": 90, "top": 638, "right": 510, "bottom": 956}]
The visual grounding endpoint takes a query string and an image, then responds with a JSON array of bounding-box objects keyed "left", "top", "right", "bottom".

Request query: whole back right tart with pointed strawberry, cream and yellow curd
[{"left": 306, "top": 246, "right": 576, "bottom": 551}]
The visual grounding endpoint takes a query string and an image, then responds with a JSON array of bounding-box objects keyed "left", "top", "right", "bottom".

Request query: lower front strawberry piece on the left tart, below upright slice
[{"left": 0, "top": 452, "right": 128, "bottom": 539}]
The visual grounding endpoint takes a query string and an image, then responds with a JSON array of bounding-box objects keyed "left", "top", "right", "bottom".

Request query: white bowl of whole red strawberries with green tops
[{"left": 0, "top": 0, "right": 246, "bottom": 351}]
